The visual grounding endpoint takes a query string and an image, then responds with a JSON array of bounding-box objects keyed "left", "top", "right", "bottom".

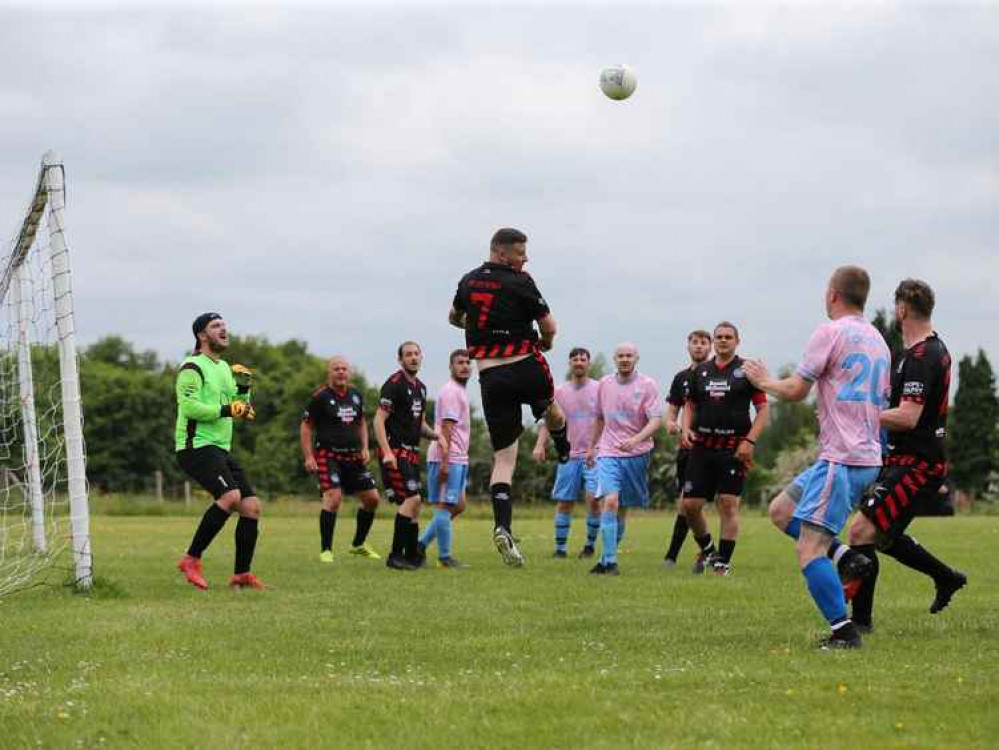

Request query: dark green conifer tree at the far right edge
[{"left": 949, "top": 349, "right": 999, "bottom": 495}]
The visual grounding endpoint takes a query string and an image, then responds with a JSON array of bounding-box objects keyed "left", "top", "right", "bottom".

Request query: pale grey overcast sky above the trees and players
[{"left": 0, "top": 2, "right": 999, "bottom": 400}]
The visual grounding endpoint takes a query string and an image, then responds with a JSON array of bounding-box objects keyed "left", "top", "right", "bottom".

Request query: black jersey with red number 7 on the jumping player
[{"left": 453, "top": 262, "right": 549, "bottom": 359}]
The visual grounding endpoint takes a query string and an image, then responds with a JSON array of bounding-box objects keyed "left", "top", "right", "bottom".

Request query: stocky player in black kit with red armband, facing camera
[{"left": 680, "top": 321, "right": 768, "bottom": 575}]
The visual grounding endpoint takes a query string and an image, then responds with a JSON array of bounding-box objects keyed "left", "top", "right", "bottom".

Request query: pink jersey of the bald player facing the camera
[{"left": 597, "top": 372, "right": 663, "bottom": 458}]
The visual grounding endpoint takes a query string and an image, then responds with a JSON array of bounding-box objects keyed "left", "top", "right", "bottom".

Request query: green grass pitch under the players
[{"left": 0, "top": 513, "right": 999, "bottom": 750}]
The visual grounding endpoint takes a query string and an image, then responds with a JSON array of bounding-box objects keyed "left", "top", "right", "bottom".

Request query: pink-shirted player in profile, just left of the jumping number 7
[{"left": 420, "top": 349, "right": 472, "bottom": 568}]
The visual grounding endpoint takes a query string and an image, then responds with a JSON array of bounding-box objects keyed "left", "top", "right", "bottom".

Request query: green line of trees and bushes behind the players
[{"left": 9, "top": 311, "right": 999, "bottom": 506}]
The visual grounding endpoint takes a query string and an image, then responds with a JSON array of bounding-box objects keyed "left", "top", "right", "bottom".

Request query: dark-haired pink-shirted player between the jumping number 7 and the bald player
[{"left": 532, "top": 346, "right": 600, "bottom": 558}]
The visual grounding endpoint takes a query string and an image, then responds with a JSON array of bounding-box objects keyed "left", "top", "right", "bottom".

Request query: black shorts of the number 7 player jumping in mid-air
[{"left": 479, "top": 351, "right": 555, "bottom": 451}]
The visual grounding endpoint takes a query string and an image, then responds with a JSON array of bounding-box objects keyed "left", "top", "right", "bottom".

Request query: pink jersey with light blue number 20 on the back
[{"left": 797, "top": 315, "right": 891, "bottom": 466}]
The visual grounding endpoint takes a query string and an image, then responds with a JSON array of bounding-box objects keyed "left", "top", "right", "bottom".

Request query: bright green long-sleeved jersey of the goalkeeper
[{"left": 174, "top": 354, "right": 249, "bottom": 451}]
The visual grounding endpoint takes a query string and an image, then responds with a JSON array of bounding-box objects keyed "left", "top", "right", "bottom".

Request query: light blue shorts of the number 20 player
[{"left": 788, "top": 461, "right": 881, "bottom": 534}]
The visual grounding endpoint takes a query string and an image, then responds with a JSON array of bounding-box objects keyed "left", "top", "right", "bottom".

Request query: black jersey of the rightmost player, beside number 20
[{"left": 888, "top": 333, "right": 951, "bottom": 463}]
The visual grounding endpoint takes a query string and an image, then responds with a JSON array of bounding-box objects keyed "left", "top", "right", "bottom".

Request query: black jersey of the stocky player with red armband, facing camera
[{"left": 687, "top": 357, "right": 767, "bottom": 440}]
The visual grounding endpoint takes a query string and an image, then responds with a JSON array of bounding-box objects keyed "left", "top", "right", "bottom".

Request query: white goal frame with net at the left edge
[{"left": 0, "top": 151, "right": 93, "bottom": 596}]
